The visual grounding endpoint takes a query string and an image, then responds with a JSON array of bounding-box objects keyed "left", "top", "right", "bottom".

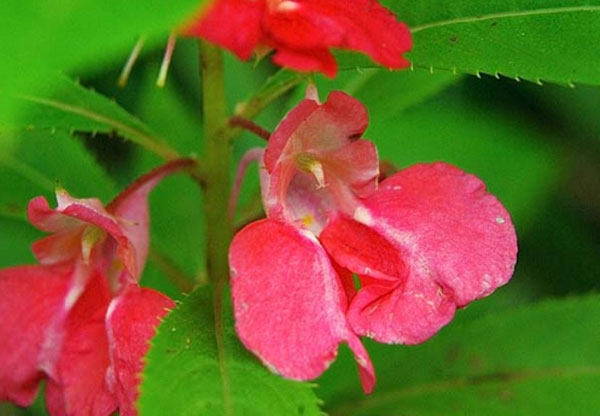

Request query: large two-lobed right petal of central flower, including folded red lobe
[{"left": 320, "top": 163, "right": 516, "bottom": 344}]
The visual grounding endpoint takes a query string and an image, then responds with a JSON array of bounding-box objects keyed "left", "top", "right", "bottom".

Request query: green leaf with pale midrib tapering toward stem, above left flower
[{"left": 4, "top": 76, "right": 176, "bottom": 158}]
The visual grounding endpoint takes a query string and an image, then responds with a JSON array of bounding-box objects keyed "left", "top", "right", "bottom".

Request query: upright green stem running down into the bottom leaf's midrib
[{"left": 199, "top": 41, "right": 233, "bottom": 415}]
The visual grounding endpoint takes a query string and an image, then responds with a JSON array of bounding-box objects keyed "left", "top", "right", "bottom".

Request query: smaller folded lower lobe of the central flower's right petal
[{"left": 319, "top": 216, "right": 455, "bottom": 344}]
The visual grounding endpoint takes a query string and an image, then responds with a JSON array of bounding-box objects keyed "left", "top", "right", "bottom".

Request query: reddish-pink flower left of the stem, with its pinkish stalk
[{"left": 0, "top": 160, "right": 189, "bottom": 416}]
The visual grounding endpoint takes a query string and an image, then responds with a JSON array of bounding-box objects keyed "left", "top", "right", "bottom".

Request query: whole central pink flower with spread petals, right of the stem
[{"left": 230, "top": 92, "right": 517, "bottom": 393}]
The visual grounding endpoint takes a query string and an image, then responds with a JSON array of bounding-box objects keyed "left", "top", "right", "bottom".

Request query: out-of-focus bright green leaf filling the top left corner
[{"left": 0, "top": 0, "right": 206, "bottom": 118}]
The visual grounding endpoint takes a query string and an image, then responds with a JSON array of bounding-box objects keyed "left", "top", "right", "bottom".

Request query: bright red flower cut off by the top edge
[{"left": 183, "top": 0, "right": 412, "bottom": 77}]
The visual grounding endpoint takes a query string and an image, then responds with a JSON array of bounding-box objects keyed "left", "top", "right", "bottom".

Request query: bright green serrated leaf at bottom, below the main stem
[{"left": 138, "top": 288, "right": 321, "bottom": 416}]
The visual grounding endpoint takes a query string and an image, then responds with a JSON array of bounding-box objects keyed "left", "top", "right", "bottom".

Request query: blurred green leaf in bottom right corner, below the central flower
[{"left": 319, "top": 296, "right": 600, "bottom": 416}]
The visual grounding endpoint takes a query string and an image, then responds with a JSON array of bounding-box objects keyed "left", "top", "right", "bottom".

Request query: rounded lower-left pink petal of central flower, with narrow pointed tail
[{"left": 229, "top": 219, "right": 374, "bottom": 391}]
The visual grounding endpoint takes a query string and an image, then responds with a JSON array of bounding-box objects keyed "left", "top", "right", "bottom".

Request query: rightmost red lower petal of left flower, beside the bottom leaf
[{"left": 106, "top": 285, "right": 175, "bottom": 416}]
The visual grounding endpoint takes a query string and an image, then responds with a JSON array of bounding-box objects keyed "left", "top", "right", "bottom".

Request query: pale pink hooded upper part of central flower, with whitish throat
[{"left": 263, "top": 91, "right": 372, "bottom": 228}]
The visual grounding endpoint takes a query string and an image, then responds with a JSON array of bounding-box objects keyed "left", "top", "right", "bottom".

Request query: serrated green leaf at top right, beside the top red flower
[{"left": 340, "top": 0, "right": 600, "bottom": 85}]
